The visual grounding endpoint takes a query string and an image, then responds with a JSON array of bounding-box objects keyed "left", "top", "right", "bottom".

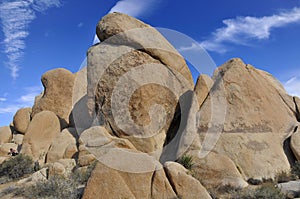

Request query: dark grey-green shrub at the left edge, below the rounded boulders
[{"left": 0, "top": 154, "right": 34, "bottom": 180}]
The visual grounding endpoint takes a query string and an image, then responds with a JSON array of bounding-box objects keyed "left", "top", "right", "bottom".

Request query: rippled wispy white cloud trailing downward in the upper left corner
[{"left": 0, "top": 0, "right": 61, "bottom": 79}]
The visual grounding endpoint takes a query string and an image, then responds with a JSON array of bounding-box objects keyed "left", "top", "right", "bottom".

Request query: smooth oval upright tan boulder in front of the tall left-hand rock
[{"left": 21, "top": 111, "right": 60, "bottom": 164}]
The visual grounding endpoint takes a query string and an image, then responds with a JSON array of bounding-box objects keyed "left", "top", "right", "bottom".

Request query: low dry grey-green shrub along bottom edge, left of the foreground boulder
[{"left": 15, "top": 175, "right": 79, "bottom": 199}]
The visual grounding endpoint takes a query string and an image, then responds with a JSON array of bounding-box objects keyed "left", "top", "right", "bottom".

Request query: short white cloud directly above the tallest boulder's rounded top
[{"left": 109, "top": 0, "right": 158, "bottom": 17}]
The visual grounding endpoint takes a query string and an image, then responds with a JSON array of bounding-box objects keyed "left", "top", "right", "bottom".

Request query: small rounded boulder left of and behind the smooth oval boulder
[{"left": 13, "top": 108, "right": 32, "bottom": 134}]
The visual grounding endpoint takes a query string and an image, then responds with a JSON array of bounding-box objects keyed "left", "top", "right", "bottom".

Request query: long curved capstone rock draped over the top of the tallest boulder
[{"left": 96, "top": 13, "right": 194, "bottom": 87}]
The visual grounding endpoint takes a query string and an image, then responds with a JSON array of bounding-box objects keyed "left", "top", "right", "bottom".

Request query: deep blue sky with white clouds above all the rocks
[{"left": 0, "top": 0, "right": 300, "bottom": 126}]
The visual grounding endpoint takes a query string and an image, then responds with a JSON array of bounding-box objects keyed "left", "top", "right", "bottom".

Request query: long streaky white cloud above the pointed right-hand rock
[{"left": 201, "top": 7, "right": 300, "bottom": 53}]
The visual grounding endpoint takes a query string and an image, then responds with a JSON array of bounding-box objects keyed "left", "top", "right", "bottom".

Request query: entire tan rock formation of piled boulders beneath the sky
[{"left": 0, "top": 13, "right": 300, "bottom": 199}]
